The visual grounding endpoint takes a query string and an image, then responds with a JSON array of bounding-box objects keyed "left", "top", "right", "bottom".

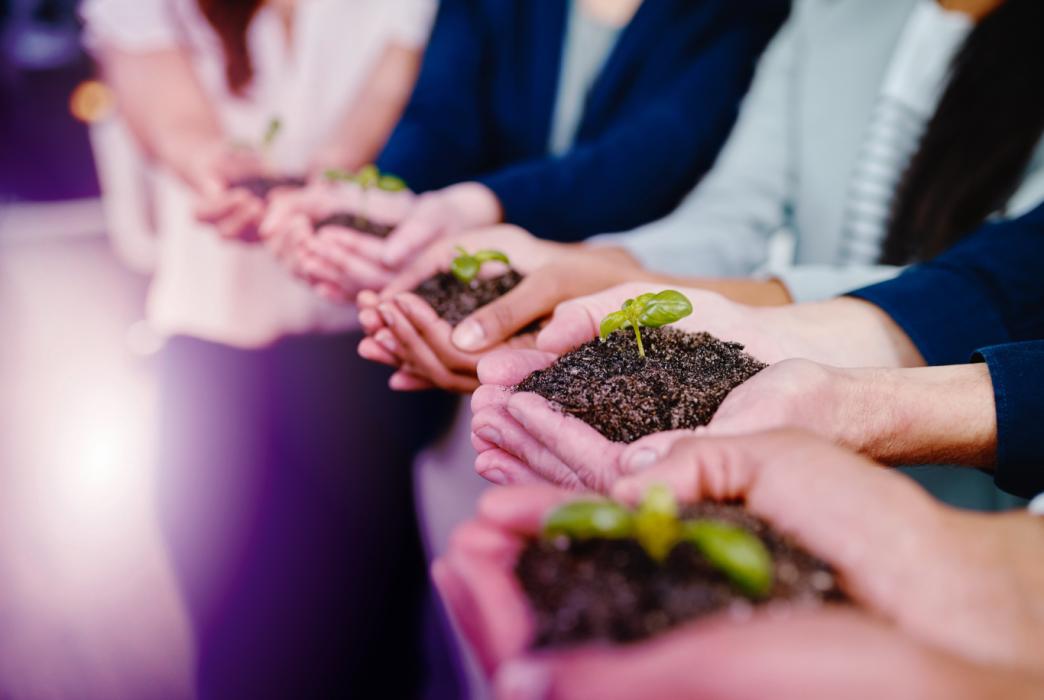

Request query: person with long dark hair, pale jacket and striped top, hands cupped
[{"left": 359, "top": 0, "right": 1044, "bottom": 391}]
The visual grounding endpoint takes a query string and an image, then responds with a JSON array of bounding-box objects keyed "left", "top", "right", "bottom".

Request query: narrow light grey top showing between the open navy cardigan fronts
[{"left": 549, "top": 0, "right": 623, "bottom": 156}]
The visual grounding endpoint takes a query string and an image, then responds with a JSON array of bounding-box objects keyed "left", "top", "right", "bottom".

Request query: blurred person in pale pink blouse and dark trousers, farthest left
[{"left": 76, "top": 0, "right": 438, "bottom": 698}]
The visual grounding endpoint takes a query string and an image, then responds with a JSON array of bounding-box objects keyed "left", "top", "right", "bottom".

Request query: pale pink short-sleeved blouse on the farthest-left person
[{"left": 81, "top": 0, "right": 433, "bottom": 347}]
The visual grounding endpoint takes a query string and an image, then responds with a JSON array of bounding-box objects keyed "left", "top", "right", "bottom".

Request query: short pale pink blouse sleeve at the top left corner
[{"left": 79, "top": 0, "right": 183, "bottom": 52}]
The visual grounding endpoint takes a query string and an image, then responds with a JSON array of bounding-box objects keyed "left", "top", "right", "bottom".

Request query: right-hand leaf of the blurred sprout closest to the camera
[{"left": 682, "top": 520, "right": 773, "bottom": 598}]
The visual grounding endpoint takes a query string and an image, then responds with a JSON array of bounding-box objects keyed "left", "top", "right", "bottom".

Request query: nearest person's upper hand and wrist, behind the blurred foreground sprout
[{"left": 613, "top": 430, "right": 1044, "bottom": 669}]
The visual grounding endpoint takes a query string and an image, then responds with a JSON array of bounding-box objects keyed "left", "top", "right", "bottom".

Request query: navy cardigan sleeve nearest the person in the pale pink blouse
[{"left": 377, "top": 0, "right": 489, "bottom": 192}]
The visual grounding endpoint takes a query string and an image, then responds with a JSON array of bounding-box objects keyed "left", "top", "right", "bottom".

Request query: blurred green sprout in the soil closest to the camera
[{"left": 543, "top": 485, "right": 774, "bottom": 600}]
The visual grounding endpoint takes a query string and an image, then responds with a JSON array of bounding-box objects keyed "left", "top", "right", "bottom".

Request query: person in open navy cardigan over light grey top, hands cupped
[{"left": 266, "top": 0, "right": 789, "bottom": 299}]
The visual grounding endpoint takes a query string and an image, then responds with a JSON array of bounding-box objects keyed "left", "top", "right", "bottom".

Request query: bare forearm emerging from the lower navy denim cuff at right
[{"left": 836, "top": 365, "right": 997, "bottom": 468}]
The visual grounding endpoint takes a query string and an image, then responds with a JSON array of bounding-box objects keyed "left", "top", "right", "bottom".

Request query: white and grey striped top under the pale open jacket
[{"left": 839, "top": 2, "right": 974, "bottom": 265}]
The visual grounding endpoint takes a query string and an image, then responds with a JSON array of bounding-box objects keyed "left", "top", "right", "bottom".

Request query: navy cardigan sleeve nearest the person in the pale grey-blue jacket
[{"left": 478, "top": 0, "right": 787, "bottom": 240}]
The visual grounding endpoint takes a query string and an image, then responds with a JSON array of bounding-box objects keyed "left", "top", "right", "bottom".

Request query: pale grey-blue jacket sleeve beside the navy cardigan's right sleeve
[{"left": 592, "top": 9, "right": 798, "bottom": 276}]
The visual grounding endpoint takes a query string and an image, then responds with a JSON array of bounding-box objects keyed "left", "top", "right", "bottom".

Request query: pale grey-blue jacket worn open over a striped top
[{"left": 598, "top": 0, "right": 1044, "bottom": 301}]
